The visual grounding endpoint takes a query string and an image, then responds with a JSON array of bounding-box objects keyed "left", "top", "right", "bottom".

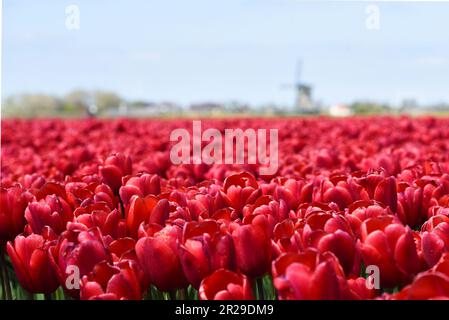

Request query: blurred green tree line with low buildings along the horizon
[{"left": 2, "top": 90, "right": 449, "bottom": 118}]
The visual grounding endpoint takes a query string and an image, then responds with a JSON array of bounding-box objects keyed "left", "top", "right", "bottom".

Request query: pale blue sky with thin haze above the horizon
[{"left": 2, "top": 0, "right": 449, "bottom": 105}]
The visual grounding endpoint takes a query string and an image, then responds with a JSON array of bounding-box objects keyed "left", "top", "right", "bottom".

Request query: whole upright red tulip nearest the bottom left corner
[{"left": 6, "top": 234, "right": 59, "bottom": 293}]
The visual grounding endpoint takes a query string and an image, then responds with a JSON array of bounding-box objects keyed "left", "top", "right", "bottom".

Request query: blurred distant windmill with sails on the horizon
[{"left": 283, "top": 59, "right": 319, "bottom": 113}]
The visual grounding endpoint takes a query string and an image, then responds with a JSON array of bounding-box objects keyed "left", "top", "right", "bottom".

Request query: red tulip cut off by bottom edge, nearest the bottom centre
[{"left": 198, "top": 269, "right": 253, "bottom": 300}]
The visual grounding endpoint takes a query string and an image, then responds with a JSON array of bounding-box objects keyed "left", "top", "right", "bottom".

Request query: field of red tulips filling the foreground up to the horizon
[{"left": 0, "top": 117, "right": 449, "bottom": 300}]
